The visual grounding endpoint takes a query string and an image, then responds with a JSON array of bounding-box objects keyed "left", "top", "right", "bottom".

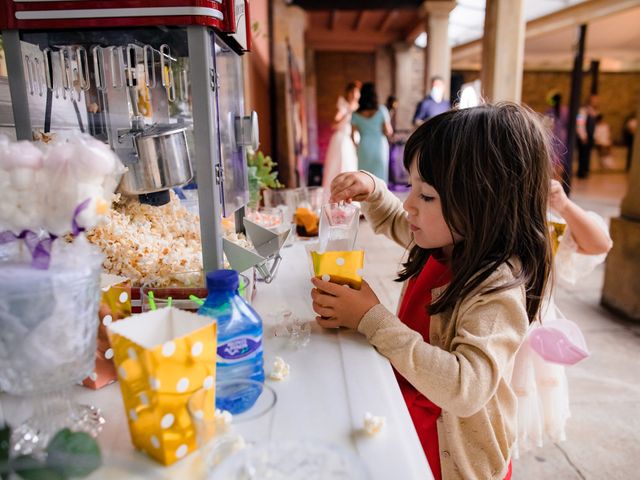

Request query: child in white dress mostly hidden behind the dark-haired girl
[{"left": 511, "top": 180, "right": 612, "bottom": 458}]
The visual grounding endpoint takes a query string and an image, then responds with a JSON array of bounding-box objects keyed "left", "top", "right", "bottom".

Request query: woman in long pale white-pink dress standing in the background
[{"left": 322, "top": 82, "right": 361, "bottom": 189}]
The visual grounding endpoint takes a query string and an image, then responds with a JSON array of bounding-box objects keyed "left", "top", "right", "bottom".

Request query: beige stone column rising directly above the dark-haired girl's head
[{"left": 481, "top": 0, "right": 526, "bottom": 103}]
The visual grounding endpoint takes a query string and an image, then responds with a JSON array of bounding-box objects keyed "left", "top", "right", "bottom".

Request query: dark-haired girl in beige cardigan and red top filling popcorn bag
[{"left": 311, "top": 104, "right": 551, "bottom": 480}]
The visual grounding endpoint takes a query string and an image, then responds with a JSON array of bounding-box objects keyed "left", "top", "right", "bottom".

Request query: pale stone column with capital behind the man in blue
[{"left": 423, "top": 0, "right": 456, "bottom": 98}]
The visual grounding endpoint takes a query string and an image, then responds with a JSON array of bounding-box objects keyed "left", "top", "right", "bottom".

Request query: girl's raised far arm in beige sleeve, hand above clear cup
[{"left": 331, "top": 171, "right": 413, "bottom": 247}]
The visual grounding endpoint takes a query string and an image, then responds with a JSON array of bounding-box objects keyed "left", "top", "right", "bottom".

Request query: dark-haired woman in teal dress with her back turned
[{"left": 351, "top": 83, "right": 393, "bottom": 182}]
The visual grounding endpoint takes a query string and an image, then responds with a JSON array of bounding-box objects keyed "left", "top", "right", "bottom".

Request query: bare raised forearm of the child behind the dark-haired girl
[{"left": 549, "top": 180, "right": 613, "bottom": 255}]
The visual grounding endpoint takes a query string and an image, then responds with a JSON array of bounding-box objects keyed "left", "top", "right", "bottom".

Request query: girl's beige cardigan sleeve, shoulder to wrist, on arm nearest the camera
[{"left": 358, "top": 288, "right": 528, "bottom": 417}]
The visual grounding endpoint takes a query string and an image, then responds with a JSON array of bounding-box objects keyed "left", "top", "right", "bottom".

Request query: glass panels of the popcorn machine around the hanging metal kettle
[{"left": 10, "top": 27, "right": 248, "bottom": 216}]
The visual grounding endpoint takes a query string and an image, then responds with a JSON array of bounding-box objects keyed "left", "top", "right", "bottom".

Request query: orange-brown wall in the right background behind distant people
[{"left": 460, "top": 71, "right": 640, "bottom": 143}]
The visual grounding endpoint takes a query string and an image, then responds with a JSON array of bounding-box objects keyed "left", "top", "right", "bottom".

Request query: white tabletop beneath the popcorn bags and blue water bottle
[{"left": 5, "top": 243, "right": 433, "bottom": 480}]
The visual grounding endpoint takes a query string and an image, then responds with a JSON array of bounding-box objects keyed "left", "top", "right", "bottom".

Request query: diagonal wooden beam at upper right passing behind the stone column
[{"left": 451, "top": 0, "right": 638, "bottom": 63}]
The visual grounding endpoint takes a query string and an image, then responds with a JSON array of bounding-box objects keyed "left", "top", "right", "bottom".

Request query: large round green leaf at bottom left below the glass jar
[{"left": 47, "top": 428, "right": 102, "bottom": 477}]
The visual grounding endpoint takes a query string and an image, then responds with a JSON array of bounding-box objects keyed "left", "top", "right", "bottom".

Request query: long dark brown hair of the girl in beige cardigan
[{"left": 398, "top": 103, "right": 552, "bottom": 321}]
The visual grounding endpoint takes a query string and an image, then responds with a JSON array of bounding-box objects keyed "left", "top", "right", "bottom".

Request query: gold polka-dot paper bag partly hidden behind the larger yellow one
[{"left": 82, "top": 273, "right": 131, "bottom": 390}]
